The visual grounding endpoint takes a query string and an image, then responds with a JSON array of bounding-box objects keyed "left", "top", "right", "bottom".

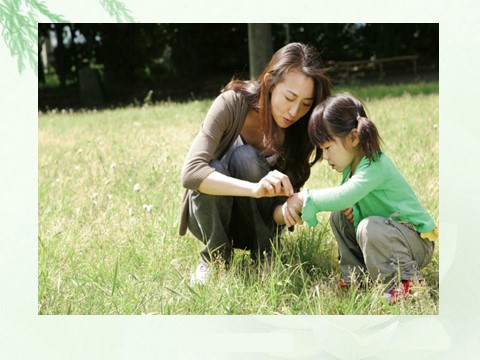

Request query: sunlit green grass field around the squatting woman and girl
[{"left": 38, "top": 82, "right": 439, "bottom": 314}]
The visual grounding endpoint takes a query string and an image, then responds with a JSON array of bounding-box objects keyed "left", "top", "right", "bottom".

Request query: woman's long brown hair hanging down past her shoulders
[{"left": 222, "top": 43, "right": 332, "bottom": 191}]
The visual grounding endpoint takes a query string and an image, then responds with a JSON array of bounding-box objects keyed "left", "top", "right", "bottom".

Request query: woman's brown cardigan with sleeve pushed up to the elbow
[{"left": 179, "top": 90, "right": 248, "bottom": 235}]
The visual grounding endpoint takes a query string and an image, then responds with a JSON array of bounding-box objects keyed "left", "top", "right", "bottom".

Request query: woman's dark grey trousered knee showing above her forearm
[{"left": 228, "top": 145, "right": 270, "bottom": 181}]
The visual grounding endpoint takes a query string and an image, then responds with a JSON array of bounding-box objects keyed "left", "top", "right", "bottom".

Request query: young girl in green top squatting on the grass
[{"left": 287, "top": 93, "right": 437, "bottom": 300}]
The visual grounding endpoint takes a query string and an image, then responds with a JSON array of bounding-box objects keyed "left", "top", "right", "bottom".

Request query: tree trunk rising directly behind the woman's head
[{"left": 248, "top": 24, "right": 273, "bottom": 80}]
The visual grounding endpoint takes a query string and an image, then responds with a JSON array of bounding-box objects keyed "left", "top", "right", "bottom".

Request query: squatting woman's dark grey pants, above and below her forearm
[{"left": 188, "top": 145, "right": 286, "bottom": 262}]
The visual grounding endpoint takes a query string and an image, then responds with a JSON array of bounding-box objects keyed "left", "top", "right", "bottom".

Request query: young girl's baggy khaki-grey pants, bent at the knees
[{"left": 330, "top": 211, "right": 434, "bottom": 288}]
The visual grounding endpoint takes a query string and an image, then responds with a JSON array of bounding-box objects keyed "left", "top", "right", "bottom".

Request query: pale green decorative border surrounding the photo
[{"left": 0, "top": 0, "right": 480, "bottom": 360}]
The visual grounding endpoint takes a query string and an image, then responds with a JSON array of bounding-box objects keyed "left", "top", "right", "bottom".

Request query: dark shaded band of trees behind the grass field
[{"left": 39, "top": 23, "right": 438, "bottom": 106}]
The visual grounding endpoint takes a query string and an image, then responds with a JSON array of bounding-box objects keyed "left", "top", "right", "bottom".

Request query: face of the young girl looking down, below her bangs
[{"left": 320, "top": 130, "right": 363, "bottom": 173}]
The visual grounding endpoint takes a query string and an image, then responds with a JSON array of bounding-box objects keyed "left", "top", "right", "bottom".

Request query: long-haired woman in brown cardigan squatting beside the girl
[{"left": 180, "top": 43, "right": 331, "bottom": 283}]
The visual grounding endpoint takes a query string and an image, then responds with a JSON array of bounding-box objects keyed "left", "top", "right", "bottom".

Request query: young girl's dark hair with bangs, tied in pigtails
[{"left": 308, "top": 93, "right": 382, "bottom": 161}]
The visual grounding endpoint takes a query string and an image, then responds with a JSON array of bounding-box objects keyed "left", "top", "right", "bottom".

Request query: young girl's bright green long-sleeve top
[{"left": 302, "top": 153, "right": 435, "bottom": 233}]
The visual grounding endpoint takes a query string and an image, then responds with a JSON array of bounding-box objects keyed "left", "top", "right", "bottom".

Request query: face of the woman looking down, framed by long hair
[{"left": 270, "top": 70, "right": 315, "bottom": 129}]
